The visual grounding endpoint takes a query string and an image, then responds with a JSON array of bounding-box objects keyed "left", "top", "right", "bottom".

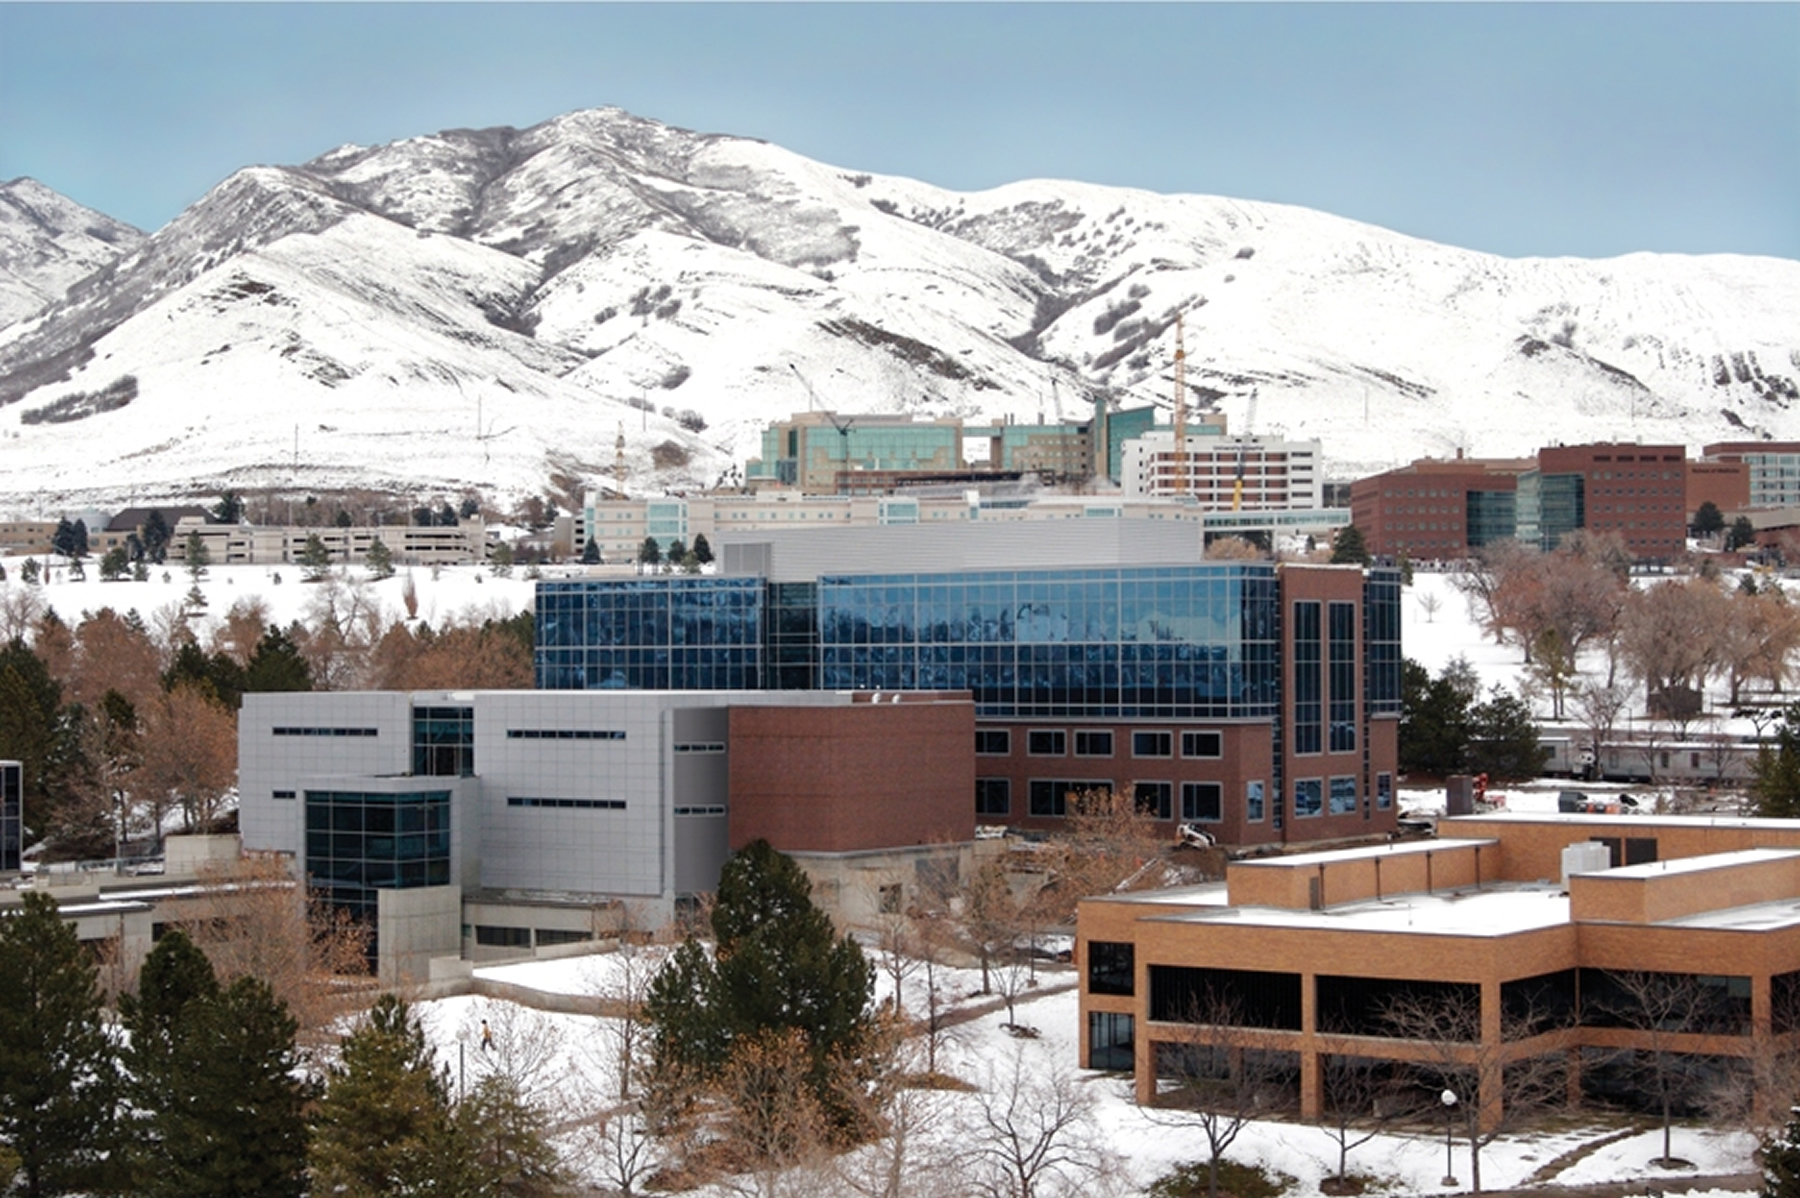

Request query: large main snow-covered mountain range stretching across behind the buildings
[{"left": 0, "top": 110, "right": 1800, "bottom": 507}]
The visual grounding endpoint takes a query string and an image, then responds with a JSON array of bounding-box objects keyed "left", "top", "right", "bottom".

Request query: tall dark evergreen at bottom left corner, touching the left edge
[{"left": 0, "top": 890, "right": 119, "bottom": 1198}]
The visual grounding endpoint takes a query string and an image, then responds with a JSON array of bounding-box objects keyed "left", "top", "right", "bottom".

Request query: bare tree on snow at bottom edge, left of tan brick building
[{"left": 961, "top": 1045, "right": 1112, "bottom": 1198}]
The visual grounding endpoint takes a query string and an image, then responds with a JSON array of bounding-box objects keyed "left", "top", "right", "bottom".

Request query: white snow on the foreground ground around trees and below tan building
[{"left": 419, "top": 953, "right": 1755, "bottom": 1198}]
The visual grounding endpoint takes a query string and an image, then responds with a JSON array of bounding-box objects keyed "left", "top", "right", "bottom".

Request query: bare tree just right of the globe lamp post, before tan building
[{"left": 1381, "top": 984, "right": 1568, "bottom": 1194}]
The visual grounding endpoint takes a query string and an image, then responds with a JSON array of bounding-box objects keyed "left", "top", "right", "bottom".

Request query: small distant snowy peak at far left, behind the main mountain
[{"left": 0, "top": 178, "right": 144, "bottom": 327}]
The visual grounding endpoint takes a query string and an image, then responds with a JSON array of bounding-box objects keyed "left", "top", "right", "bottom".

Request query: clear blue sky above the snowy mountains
[{"left": 0, "top": 4, "right": 1800, "bottom": 259}]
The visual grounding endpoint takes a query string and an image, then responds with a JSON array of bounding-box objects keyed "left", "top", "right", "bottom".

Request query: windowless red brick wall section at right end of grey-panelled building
[{"left": 731, "top": 696, "right": 976, "bottom": 853}]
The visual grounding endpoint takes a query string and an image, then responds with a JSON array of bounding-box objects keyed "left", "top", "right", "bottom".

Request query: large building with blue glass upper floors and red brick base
[{"left": 536, "top": 520, "right": 1400, "bottom": 844}]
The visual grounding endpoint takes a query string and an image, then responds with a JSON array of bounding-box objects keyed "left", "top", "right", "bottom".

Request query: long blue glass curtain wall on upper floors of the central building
[{"left": 536, "top": 563, "right": 1280, "bottom": 720}]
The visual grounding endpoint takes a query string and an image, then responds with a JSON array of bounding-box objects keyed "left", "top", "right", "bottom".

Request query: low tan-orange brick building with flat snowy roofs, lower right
[{"left": 1076, "top": 815, "right": 1800, "bottom": 1122}]
